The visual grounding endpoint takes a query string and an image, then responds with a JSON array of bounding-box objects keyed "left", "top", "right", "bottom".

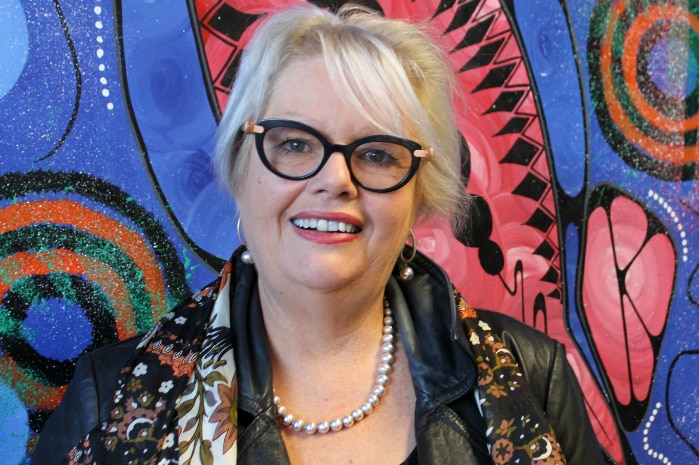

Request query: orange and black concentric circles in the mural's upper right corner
[{"left": 587, "top": 0, "right": 699, "bottom": 181}]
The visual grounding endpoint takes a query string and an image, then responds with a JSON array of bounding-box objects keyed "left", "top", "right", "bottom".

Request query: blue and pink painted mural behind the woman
[{"left": 0, "top": 0, "right": 699, "bottom": 465}]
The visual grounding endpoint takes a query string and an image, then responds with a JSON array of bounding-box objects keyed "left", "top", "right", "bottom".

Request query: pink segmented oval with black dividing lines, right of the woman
[{"left": 583, "top": 197, "right": 676, "bottom": 405}]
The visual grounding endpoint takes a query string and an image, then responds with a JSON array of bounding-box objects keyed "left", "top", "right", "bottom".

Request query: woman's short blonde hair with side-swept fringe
[{"left": 214, "top": 5, "right": 468, "bottom": 228}]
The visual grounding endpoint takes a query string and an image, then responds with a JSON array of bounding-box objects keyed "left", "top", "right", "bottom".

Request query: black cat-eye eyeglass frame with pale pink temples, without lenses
[{"left": 241, "top": 118, "right": 434, "bottom": 193}]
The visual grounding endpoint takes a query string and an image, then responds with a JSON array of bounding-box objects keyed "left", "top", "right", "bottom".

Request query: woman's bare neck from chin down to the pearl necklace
[{"left": 260, "top": 280, "right": 394, "bottom": 430}]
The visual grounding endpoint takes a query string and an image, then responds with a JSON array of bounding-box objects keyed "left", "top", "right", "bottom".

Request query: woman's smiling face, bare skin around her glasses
[{"left": 237, "top": 57, "right": 417, "bottom": 292}]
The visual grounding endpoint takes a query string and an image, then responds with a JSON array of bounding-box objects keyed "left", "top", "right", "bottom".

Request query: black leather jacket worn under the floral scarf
[{"left": 33, "top": 255, "right": 604, "bottom": 465}]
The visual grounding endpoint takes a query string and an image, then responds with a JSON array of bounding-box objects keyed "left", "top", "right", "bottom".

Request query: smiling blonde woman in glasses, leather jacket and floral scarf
[{"left": 35, "top": 6, "right": 600, "bottom": 464}]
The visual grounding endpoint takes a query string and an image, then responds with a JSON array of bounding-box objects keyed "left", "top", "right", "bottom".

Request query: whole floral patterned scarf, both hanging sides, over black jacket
[{"left": 63, "top": 253, "right": 565, "bottom": 465}]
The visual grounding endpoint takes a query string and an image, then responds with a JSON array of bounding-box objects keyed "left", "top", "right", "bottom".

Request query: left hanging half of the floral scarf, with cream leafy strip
[{"left": 63, "top": 262, "right": 238, "bottom": 465}]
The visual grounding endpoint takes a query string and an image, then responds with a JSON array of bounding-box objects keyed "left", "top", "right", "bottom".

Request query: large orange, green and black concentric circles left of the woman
[{"left": 0, "top": 171, "right": 190, "bottom": 442}]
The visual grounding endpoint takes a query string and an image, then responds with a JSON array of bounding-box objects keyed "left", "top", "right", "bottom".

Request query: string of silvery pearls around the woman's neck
[{"left": 274, "top": 297, "right": 395, "bottom": 434}]
